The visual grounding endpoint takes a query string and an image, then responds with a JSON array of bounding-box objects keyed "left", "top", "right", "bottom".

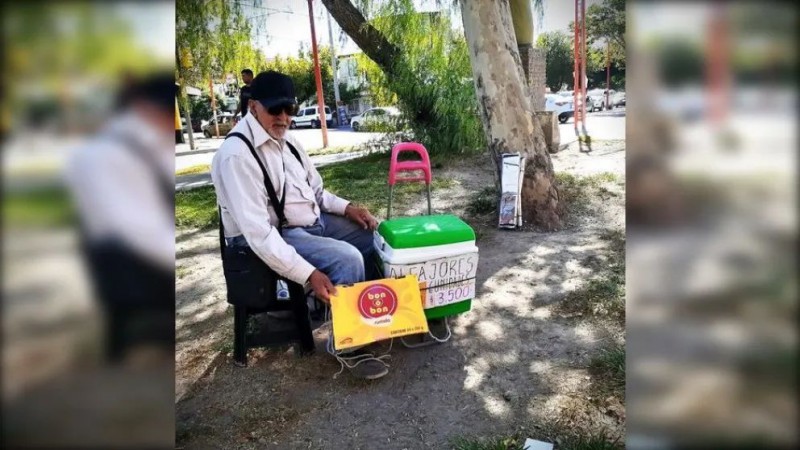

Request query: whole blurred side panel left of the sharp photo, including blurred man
[{"left": 0, "top": 1, "right": 175, "bottom": 448}]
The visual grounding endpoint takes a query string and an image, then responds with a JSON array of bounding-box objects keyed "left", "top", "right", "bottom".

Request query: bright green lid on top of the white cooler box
[{"left": 378, "top": 214, "right": 475, "bottom": 249}]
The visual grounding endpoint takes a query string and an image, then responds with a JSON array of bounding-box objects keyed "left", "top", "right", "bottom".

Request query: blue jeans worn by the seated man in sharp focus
[{"left": 227, "top": 213, "right": 381, "bottom": 284}]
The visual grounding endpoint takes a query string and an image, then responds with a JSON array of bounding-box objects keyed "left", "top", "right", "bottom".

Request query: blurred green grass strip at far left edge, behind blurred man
[{"left": 3, "top": 187, "right": 77, "bottom": 228}]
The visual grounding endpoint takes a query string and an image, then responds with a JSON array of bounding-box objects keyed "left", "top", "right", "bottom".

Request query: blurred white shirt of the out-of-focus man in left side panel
[{"left": 64, "top": 112, "right": 175, "bottom": 271}]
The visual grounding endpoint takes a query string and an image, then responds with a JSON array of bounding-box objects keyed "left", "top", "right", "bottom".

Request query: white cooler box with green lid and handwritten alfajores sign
[{"left": 375, "top": 214, "right": 478, "bottom": 320}]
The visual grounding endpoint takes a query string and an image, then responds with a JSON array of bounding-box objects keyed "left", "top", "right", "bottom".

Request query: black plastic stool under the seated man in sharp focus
[{"left": 233, "top": 272, "right": 314, "bottom": 367}]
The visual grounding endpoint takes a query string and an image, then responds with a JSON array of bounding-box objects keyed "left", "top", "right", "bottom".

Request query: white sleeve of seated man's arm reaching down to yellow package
[{"left": 215, "top": 155, "right": 314, "bottom": 284}]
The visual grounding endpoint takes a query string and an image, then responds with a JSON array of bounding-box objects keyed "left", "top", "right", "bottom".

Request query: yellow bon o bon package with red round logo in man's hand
[{"left": 331, "top": 275, "right": 428, "bottom": 350}]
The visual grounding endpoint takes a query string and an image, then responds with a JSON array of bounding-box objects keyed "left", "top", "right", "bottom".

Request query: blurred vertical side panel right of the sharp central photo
[{"left": 626, "top": 0, "right": 798, "bottom": 449}]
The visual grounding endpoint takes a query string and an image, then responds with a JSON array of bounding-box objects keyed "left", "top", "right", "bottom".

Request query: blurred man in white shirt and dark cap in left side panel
[{"left": 67, "top": 72, "right": 177, "bottom": 368}]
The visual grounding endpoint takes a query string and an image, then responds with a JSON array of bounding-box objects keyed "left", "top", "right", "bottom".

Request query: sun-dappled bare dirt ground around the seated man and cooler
[{"left": 176, "top": 141, "right": 625, "bottom": 449}]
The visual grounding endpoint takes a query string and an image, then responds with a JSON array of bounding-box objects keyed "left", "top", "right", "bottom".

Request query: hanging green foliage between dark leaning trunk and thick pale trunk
[{"left": 348, "top": 0, "right": 486, "bottom": 154}]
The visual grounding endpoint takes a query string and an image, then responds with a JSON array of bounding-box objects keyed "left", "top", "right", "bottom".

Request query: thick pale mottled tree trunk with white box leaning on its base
[{"left": 461, "top": 0, "right": 561, "bottom": 230}]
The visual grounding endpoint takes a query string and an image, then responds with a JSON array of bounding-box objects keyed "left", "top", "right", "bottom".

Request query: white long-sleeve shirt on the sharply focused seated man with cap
[{"left": 211, "top": 114, "right": 349, "bottom": 284}]
